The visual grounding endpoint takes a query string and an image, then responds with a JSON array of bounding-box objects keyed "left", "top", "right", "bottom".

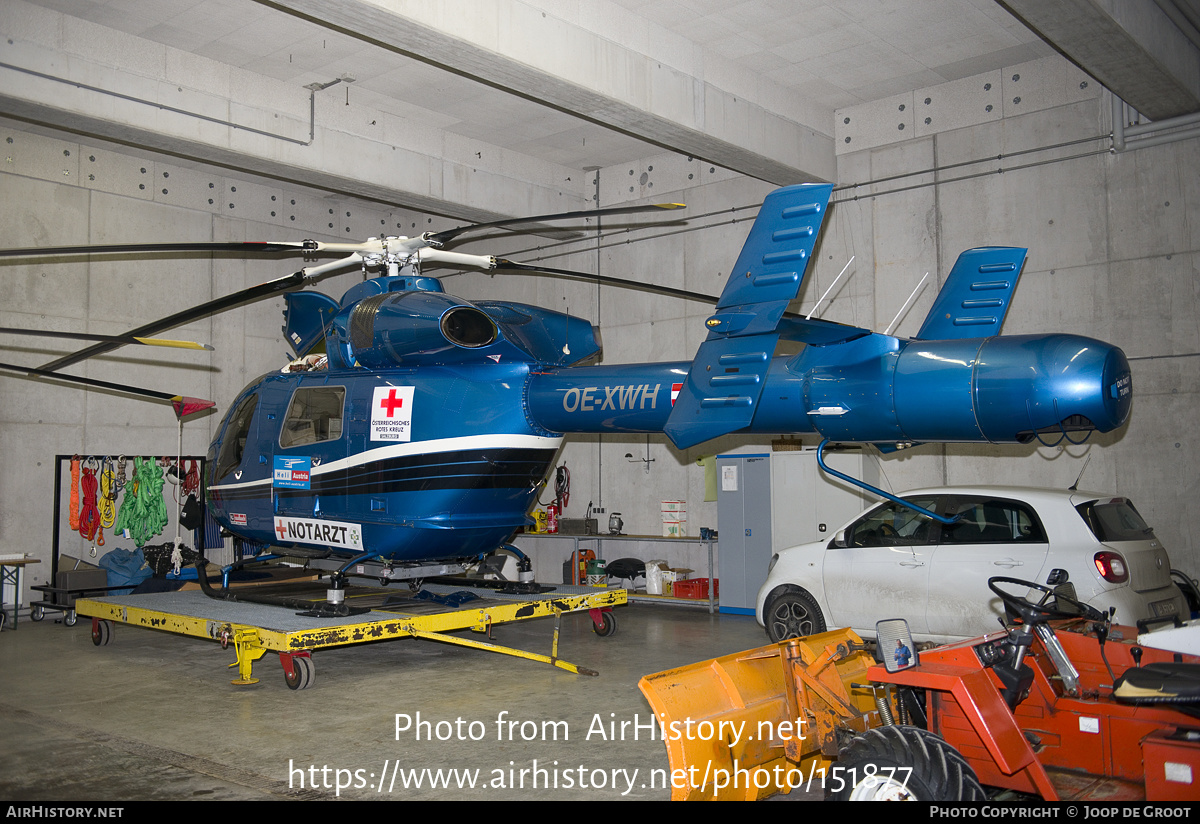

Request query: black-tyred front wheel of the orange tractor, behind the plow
[{"left": 827, "top": 727, "right": 988, "bottom": 801}]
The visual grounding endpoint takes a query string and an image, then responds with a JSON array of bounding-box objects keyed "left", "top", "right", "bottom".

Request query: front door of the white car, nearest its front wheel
[{"left": 822, "top": 495, "right": 938, "bottom": 634}]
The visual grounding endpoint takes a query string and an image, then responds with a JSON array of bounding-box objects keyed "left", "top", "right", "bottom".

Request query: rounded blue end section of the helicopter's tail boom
[{"left": 976, "top": 335, "right": 1133, "bottom": 441}]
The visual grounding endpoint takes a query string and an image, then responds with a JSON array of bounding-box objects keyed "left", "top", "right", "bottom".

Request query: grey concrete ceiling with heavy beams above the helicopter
[{"left": 0, "top": 0, "right": 1200, "bottom": 215}]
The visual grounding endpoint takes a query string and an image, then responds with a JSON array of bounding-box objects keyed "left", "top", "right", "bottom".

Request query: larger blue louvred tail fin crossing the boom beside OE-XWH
[{"left": 664, "top": 184, "right": 833, "bottom": 449}]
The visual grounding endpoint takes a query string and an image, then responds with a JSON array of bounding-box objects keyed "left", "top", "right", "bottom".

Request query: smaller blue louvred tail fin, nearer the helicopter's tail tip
[{"left": 917, "top": 246, "right": 1028, "bottom": 341}]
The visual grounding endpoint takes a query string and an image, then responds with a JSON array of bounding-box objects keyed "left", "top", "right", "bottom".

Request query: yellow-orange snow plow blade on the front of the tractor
[{"left": 637, "top": 630, "right": 880, "bottom": 801}]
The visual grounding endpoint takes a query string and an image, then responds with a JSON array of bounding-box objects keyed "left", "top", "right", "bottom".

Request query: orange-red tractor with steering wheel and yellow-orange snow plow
[{"left": 638, "top": 578, "right": 1200, "bottom": 801}]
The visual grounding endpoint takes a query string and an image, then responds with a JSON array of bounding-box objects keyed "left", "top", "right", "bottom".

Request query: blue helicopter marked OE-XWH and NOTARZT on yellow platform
[{"left": 0, "top": 185, "right": 1132, "bottom": 611}]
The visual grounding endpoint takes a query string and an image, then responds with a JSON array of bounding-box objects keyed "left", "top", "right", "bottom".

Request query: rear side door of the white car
[{"left": 925, "top": 495, "right": 1049, "bottom": 638}]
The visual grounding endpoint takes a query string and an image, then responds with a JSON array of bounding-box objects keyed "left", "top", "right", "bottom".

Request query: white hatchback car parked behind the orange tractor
[{"left": 755, "top": 487, "right": 1188, "bottom": 643}]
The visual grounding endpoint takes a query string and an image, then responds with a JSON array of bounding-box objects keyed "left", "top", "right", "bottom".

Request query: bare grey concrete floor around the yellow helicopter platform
[{"left": 0, "top": 605, "right": 820, "bottom": 801}]
